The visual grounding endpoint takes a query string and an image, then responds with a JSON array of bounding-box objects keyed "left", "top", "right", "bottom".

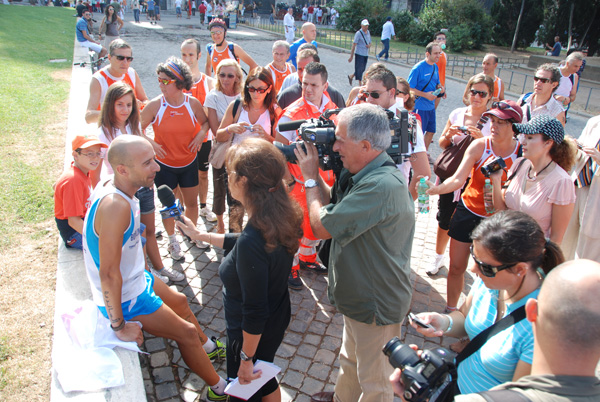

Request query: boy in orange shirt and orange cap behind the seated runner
[{"left": 54, "top": 135, "right": 107, "bottom": 250}]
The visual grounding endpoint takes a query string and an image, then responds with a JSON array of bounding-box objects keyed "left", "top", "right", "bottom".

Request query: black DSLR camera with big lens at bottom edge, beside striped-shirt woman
[{"left": 383, "top": 337, "right": 456, "bottom": 402}]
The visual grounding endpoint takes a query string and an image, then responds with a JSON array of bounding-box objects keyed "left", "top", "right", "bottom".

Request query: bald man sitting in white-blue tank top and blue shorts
[{"left": 83, "top": 135, "right": 231, "bottom": 400}]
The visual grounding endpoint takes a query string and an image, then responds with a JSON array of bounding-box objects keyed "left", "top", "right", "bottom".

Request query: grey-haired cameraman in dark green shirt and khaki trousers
[{"left": 295, "top": 104, "right": 415, "bottom": 402}]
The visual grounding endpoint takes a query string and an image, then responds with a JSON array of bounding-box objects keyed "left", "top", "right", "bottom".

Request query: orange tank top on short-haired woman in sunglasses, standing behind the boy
[{"left": 152, "top": 94, "right": 202, "bottom": 167}]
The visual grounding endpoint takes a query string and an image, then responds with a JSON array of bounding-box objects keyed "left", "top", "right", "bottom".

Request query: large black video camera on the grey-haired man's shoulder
[{"left": 274, "top": 109, "right": 417, "bottom": 176}]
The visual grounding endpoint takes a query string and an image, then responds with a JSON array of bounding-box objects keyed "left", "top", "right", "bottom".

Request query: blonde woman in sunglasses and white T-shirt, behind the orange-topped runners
[{"left": 204, "top": 59, "right": 244, "bottom": 233}]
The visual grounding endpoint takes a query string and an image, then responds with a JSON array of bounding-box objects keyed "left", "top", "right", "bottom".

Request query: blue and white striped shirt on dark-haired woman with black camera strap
[{"left": 458, "top": 278, "right": 539, "bottom": 394}]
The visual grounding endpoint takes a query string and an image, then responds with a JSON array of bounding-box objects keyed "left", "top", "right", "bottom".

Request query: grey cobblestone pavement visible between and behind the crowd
[{"left": 103, "top": 13, "right": 585, "bottom": 402}]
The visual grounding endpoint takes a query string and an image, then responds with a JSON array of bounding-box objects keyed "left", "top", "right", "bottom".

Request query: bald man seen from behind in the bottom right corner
[{"left": 455, "top": 260, "right": 600, "bottom": 402}]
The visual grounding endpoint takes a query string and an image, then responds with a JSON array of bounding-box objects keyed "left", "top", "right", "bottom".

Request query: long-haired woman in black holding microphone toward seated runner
[{"left": 177, "top": 138, "right": 303, "bottom": 402}]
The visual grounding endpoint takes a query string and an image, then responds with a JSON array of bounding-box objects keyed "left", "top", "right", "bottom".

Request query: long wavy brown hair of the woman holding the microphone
[{"left": 225, "top": 138, "right": 304, "bottom": 254}]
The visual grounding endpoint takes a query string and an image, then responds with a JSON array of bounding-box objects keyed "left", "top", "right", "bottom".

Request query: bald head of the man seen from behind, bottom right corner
[{"left": 536, "top": 260, "right": 600, "bottom": 353}]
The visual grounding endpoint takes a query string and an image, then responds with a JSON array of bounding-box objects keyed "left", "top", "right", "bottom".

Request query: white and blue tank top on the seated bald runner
[{"left": 83, "top": 181, "right": 146, "bottom": 306}]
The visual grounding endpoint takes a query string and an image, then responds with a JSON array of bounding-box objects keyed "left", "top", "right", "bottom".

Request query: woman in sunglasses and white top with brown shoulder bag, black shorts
[{"left": 425, "top": 74, "right": 494, "bottom": 275}]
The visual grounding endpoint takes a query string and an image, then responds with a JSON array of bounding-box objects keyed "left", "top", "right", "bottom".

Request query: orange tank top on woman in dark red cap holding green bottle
[{"left": 462, "top": 137, "right": 519, "bottom": 218}]
